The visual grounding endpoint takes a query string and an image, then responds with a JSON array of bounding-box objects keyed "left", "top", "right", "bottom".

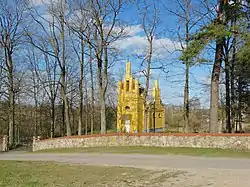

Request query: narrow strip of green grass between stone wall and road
[{"left": 35, "top": 147, "right": 250, "bottom": 158}]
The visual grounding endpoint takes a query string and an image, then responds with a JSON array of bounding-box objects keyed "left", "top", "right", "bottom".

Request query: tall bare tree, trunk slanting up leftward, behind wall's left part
[{"left": 26, "top": 0, "right": 71, "bottom": 136}]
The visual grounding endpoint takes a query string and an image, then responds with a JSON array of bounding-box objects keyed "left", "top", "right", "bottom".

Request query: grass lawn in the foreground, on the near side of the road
[{"left": 0, "top": 161, "right": 178, "bottom": 187}]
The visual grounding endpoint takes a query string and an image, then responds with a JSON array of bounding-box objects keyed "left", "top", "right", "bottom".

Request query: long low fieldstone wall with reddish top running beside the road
[{"left": 33, "top": 133, "right": 250, "bottom": 151}]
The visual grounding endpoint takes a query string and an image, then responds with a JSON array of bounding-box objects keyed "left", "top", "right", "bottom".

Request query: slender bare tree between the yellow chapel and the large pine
[{"left": 164, "top": 0, "right": 210, "bottom": 132}]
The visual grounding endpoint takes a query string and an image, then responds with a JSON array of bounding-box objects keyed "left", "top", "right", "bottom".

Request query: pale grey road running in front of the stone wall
[{"left": 0, "top": 152, "right": 250, "bottom": 187}]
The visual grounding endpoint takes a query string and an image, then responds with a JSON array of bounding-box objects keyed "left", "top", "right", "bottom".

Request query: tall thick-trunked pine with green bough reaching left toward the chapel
[{"left": 181, "top": 0, "right": 228, "bottom": 133}]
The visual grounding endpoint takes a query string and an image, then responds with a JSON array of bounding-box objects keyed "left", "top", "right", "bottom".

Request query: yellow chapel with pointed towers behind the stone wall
[{"left": 117, "top": 62, "right": 165, "bottom": 133}]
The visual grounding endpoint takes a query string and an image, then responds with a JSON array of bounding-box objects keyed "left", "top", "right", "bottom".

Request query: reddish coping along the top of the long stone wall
[{"left": 34, "top": 133, "right": 250, "bottom": 141}]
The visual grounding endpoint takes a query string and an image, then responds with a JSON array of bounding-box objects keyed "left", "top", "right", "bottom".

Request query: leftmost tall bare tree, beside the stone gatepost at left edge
[{"left": 0, "top": 0, "right": 27, "bottom": 146}]
